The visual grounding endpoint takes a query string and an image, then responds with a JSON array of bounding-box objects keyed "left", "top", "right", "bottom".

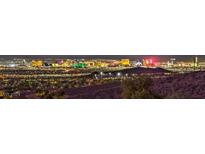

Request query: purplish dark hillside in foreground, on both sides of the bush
[{"left": 65, "top": 72, "right": 205, "bottom": 99}]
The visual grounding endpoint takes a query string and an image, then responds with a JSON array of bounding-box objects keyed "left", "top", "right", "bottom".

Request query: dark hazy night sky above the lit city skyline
[{"left": 0, "top": 55, "right": 205, "bottom": 61}]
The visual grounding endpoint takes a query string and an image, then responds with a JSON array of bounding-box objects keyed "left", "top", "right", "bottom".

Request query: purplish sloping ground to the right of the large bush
[{"left": 152, "top": 72, "right": 205, "bottom": 98}]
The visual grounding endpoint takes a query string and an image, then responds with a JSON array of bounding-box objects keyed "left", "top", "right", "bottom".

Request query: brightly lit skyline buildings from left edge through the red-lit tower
[{"left": 0, "top": 59, "right": 155, "bottom": 68}]
